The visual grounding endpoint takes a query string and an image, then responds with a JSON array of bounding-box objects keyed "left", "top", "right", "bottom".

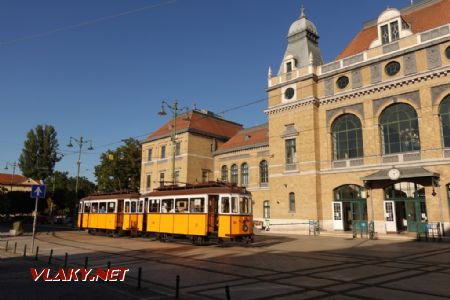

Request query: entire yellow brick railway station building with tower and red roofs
[{"left": 141, "top": 0, "right": 450, "bottom": 234}]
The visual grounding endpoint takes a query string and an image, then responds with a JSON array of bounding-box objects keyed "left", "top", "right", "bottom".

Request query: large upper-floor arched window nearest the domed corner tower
[{"left": 332, "top": 114, "right": 363, "bottom": 160}]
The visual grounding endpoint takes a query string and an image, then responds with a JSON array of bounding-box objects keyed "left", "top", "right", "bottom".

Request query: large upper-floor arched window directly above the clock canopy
[{"left": 380, "top": 103, "right": 420, "bottom": 154}]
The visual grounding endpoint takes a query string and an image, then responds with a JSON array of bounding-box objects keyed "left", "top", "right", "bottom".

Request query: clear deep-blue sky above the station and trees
[{"left": 0, "top": 0, "right": 410, "bottom": 180}]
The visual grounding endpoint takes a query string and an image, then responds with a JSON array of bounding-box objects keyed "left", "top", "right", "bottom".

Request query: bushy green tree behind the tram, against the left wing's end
[{"left": 94, "top": 138, "right": 141, "bottom": 192}]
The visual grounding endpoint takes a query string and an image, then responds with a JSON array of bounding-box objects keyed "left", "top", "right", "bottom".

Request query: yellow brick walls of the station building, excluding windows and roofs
[{"left": 141, "top": 2, "right": 450, "bottom": 237}]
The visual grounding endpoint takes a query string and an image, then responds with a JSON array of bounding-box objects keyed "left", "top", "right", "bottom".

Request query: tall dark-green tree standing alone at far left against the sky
[{"left": 19, "top": 124, "right": 61, "bottom": 179}]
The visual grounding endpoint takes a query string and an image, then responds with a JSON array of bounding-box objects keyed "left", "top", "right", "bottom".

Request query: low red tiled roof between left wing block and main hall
[{"left": 218, "top": 124, "right": 269, "bottom": 153}]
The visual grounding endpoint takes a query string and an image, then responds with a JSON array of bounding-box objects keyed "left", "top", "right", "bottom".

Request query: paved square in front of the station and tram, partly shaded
[{"left": 0, "top": 231, "right": 450, "bottom": 300}]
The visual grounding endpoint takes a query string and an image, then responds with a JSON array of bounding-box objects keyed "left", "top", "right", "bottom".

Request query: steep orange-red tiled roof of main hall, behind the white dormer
[{"left": 336, "top": 0, "right": 450, "bottom": 60}]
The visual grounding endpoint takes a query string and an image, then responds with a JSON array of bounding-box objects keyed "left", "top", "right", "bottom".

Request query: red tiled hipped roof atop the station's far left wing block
[{"left": 146, "top": 110, "right": 242, "bottom": 141}]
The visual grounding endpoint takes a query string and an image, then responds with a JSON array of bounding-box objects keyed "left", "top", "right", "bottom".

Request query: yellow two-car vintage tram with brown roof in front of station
[{"left": 78, "top": 182, "right": 253, "bottom": 244}]
